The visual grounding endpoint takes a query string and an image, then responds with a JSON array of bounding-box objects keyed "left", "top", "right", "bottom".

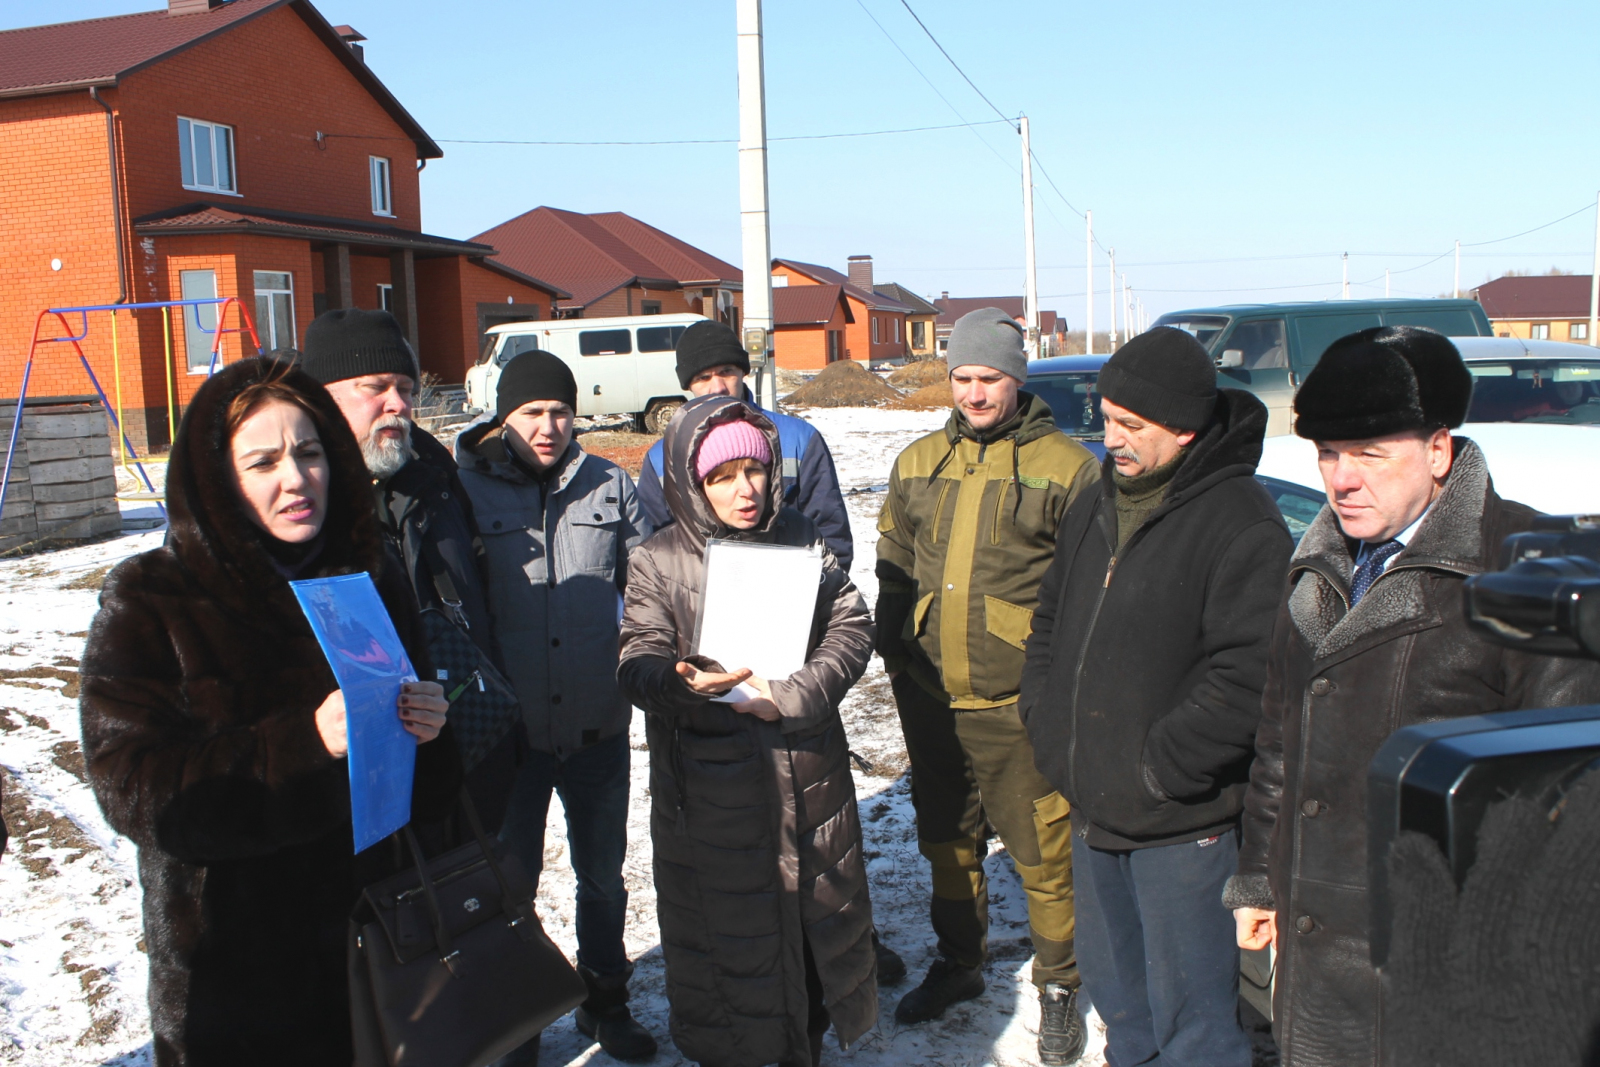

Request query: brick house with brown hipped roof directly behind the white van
[{"left": 472, "top": 208, "right": 744, "bottom": 330}]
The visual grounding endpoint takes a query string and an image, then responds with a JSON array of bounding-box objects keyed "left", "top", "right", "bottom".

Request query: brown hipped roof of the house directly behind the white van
[{"left": 472, "top": 208, "right": 741, "bottom": 307}]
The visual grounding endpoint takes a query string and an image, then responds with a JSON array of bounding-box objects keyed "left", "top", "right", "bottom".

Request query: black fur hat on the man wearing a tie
[{"left": 1294, "top": 326, "right": 1472, "bottom": 442}]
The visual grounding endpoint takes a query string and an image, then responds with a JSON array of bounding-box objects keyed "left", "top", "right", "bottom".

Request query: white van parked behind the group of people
[{"left": 467, "top": 315, "right": 704, "bottom": 434}]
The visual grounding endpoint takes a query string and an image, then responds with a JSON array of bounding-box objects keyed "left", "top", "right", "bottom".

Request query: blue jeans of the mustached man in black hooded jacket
[{"left": 1072, "top": 830, "right": 1250, "bottom": 1067}]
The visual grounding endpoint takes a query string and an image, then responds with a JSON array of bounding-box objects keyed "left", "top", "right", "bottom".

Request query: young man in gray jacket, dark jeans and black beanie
[{"left": 456, "top": 350, "right": 656, "bottom": 1064}]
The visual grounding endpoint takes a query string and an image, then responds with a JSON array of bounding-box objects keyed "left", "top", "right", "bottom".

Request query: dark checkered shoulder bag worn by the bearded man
[{"left": 422, "top": 539, "right": 522, "bottom": 771}]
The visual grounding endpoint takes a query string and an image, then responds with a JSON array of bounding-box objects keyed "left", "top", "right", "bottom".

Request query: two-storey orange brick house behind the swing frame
[{"left": 0, "top": 0, "right": 565, "bottom": 446}]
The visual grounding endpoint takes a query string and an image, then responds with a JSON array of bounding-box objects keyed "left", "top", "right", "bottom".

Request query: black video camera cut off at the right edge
[{"left": 1366, "top": 515, "right": 1600, "bottom": 966}]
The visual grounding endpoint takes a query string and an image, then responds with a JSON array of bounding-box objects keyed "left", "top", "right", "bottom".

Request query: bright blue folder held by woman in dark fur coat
[{"left": 290, "top": 573, "right": 416, "bottom": 853}]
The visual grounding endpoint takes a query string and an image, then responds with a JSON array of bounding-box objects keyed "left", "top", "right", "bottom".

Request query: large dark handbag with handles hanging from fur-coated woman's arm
[{"left": 349, "top": 792, "right": 587, "bottom": 1067}]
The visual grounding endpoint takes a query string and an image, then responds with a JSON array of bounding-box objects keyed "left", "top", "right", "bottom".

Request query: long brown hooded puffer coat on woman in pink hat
[{"left": 618, "top": 397, "right": 878, "bottom": 1067}]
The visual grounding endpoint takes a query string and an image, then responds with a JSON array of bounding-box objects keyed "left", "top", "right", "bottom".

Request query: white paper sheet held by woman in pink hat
[{"left": 694, "top": 541, "right": 822, "bottom": 701}]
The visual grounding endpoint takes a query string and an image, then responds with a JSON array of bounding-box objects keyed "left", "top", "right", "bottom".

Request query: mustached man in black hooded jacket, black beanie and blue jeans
[{"left": 1021, "top": 328, "right": 1291, "bottom": 1067}]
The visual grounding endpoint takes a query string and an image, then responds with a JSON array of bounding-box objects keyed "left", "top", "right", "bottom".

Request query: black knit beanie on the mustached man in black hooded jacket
[{"left": 1098, "top": 326, "right": 1216, "bottom": 430}]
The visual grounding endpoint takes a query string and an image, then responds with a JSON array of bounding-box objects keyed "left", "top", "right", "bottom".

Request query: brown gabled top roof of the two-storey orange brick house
[{"left": 0, "top": 0, "right": 443, "bottom": 160}]
